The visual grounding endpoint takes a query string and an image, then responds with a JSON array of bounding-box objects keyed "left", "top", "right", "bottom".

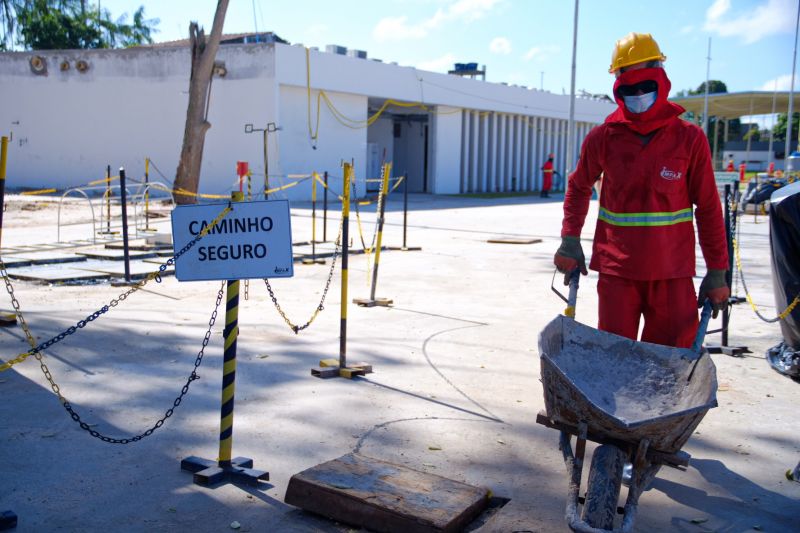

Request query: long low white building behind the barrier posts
[{"left": 0, "top": 37, "right": 614, "bottom": 199}]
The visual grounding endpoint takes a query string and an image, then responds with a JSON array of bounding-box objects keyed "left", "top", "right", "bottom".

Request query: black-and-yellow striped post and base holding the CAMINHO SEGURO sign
[{"left": 181, "top": 192, "right": 269, "bottom": 487}]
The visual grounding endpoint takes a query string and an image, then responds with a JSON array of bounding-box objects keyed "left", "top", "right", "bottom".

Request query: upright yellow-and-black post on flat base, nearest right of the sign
[{"left": 311, "top": 163, "right": 372, "bottom": 378}]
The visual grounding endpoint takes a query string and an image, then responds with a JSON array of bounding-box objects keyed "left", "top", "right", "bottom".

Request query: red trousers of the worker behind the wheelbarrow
[{"left": 597, "top": 274, "right": 699, "bottom": 348}]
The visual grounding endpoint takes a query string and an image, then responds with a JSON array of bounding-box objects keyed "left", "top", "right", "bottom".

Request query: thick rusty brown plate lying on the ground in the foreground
[{"left": 285, "top": 453, "right": 489, "bottom": 533}]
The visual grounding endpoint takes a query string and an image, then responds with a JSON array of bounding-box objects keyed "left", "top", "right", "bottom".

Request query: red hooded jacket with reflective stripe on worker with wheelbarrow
[{"left": 561, "top": 68, "right": 728, "bottom": 280}]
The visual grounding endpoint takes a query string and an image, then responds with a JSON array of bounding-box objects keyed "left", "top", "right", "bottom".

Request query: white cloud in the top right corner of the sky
[{"left": 703, "top": 0, "right": 797, "bottom": 44}]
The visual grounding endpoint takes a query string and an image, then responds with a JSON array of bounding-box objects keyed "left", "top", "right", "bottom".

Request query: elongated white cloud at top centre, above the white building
[{"left": 372, "top": 0, "right": 503, "bottom": 42}]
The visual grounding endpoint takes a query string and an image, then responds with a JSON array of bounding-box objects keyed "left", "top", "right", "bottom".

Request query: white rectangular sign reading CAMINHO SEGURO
[{"left": 172, "top": 200, "right": 294, "bottom": 281}]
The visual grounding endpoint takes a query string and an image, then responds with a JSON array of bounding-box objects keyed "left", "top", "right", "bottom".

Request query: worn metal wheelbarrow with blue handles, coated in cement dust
[{"left": 536, "top": 272, "right": 717, "bottom": 533}]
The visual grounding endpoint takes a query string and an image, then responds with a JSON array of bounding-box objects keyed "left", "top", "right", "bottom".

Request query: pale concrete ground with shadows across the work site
[{"left": 0, "top": 195, "right": 800, "bottom": 532}]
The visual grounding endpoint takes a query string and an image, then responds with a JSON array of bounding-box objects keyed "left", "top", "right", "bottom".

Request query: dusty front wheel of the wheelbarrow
[{"left": 583, "top": 444, "right": 627, "bottom": 529}]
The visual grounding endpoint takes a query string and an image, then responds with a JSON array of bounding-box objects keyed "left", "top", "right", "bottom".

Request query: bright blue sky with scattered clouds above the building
[{"left": 101, "top": 0, "right": 799, "bottom": 105}]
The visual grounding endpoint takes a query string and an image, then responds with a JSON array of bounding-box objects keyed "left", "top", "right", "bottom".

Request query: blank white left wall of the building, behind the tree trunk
[{"left": 0, "top": 45, "right": 275, "bottom": 193}]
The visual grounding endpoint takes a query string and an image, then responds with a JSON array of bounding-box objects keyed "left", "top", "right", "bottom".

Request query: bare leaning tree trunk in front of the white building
[{"left": 172, "top": 0, "right": 228, "bottom": 205}]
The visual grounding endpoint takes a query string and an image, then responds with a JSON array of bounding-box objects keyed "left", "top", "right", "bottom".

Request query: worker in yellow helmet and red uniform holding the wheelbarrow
[{"left": 554, "top": 33, "right": 730, "bottom": 347}]
